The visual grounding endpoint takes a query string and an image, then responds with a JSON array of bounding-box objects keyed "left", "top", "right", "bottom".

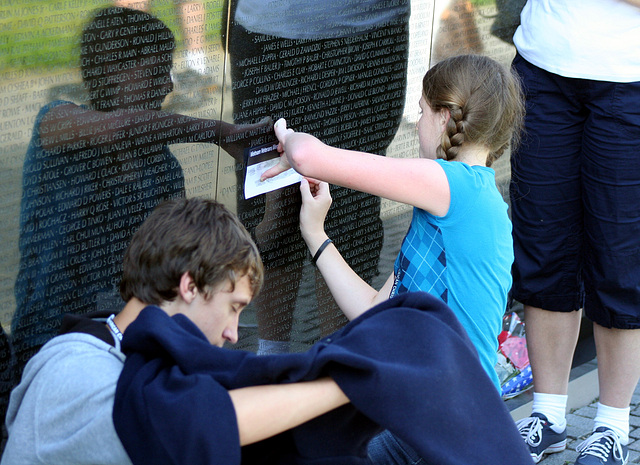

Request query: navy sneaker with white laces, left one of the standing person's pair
[{"left": 516, "top": 413, "right": 567, "bottom": 463}]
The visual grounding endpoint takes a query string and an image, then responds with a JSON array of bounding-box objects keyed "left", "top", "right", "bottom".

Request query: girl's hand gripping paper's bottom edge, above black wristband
[{"left": 300, "top": 178, "right": 331, "bottom": 239}]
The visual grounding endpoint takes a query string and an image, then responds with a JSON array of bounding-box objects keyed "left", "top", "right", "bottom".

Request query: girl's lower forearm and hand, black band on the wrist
[{"left": 300, "top": 179, "right": 392, "bottom": 320}]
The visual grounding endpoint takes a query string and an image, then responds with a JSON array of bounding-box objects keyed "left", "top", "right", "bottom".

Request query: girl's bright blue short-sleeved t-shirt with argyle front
[{"left": 391, "top": 160, "right": 513, "bottom": 387}]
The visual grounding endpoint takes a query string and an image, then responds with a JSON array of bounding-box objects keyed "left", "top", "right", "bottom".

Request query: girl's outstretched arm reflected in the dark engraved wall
[{"left": 40, "top": 103, "right": 272, "bottom": 161}]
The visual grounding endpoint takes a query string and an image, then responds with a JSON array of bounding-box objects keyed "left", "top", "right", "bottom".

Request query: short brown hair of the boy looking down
[{"left": 120, "top": 198, "right": 264, "bottom": 305}]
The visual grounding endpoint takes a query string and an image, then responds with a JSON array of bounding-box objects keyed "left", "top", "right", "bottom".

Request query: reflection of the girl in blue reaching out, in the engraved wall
[{"left": 12, "top": 7, "right": 269, "bottom": 376}]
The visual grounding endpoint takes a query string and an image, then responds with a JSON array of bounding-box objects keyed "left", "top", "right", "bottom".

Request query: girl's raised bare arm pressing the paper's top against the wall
[{"left": 263, "top": 119, "right": 450, "bottom": 216}]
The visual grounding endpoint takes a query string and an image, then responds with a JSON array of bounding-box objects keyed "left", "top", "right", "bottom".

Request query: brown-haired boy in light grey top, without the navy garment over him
[{"left": 2, "top": 198, "right": 348, "bottom": 465}]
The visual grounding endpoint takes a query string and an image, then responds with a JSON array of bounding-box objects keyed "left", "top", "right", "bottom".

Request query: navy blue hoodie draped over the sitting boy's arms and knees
[{"left": 113, "top": 292, "right": 532, "bottom": 465}]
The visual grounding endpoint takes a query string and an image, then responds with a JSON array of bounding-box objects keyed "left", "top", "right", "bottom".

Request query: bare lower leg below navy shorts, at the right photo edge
[{"left": 593, "top": 324, "right": 640, "bottom": 408}]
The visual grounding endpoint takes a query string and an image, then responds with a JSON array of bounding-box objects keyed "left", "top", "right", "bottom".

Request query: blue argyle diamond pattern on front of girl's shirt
[{"left": 390, "top": 218, "right": 448, "bottom": 303}]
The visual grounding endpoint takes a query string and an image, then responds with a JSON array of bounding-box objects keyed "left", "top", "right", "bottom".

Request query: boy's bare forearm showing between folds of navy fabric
[{"left": 229, "top": 377, "right": 349, "bottom": 446}]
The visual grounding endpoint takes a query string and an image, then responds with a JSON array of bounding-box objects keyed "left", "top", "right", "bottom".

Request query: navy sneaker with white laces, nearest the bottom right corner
[{"left": 575, "top": 426, "right": 629, "bottom": 465}]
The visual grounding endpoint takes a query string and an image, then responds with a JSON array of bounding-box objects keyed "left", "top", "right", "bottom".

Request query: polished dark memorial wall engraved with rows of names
[{"left": 0, "top": 0, "right": 524, "bottom": 357}]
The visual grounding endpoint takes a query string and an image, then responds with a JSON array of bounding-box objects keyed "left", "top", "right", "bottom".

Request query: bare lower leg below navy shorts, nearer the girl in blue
[{"left": 524, "top": 305, "right": 582, "bottom": 395}]
